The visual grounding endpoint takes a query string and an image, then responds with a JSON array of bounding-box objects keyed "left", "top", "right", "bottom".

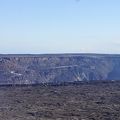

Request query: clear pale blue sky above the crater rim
[{"left": 0, "top": 0, "right": 120, "bottom": 54}]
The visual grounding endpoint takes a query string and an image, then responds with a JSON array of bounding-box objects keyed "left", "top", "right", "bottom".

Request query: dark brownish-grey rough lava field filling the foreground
[{"left": 0, "top": 81, "right": 120, "bottom": 120}]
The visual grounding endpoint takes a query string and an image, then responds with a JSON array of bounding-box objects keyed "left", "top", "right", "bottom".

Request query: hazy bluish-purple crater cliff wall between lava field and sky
[{"left": 0, "top": 54, "right": 120, "bottom": 84}]
